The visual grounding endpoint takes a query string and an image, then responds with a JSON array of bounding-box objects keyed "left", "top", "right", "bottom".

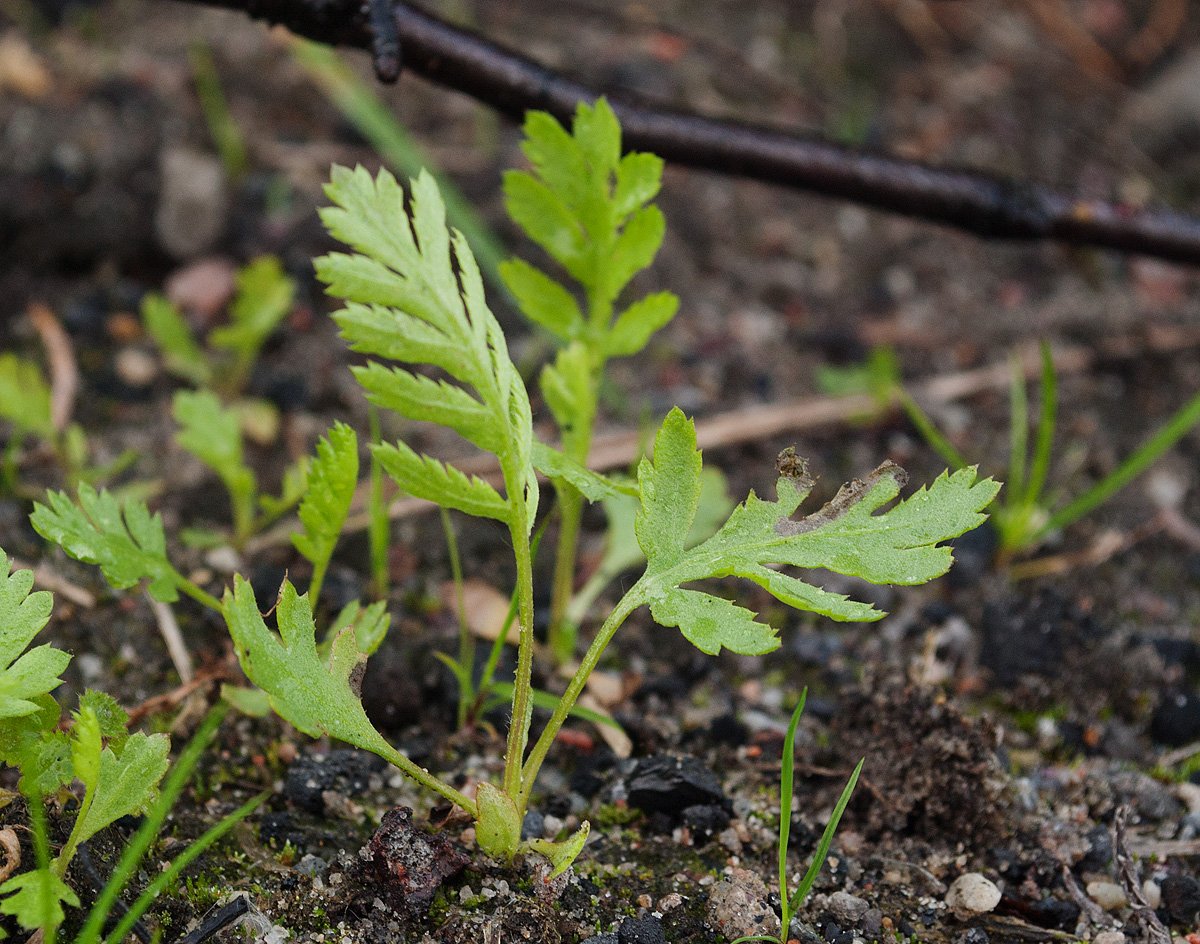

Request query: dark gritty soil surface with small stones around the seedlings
[{"left": 0, "top": 0, "right": 1200, "bottom": 944}]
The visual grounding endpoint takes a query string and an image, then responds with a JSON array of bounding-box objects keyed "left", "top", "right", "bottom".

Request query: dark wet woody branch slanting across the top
[{"left": 180, "top": 0, "right": 1200, "bottom": 264}]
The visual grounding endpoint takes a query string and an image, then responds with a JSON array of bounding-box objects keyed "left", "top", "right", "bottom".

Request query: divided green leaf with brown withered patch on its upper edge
[{"left": 635, "top": 409, "right": 1000, "bottom": 654}]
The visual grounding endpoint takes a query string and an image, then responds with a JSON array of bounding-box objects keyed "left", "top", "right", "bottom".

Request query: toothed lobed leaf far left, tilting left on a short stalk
[{"left": 30, "top": 485, "right": 184, "bottom": 603}]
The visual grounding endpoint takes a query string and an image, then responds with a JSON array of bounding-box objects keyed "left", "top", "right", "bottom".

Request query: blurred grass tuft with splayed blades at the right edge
[{"left": 822, "top": 342, "right": 1200, "bottom": 561}]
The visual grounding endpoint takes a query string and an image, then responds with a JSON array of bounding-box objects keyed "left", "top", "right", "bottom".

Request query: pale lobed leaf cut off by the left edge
[{"left": 0, "top": 551, "right": 64, "bottom": 718}]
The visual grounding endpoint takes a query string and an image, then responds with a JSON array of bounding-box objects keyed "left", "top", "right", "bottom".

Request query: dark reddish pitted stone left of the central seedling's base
[{"left": 368, "top": 806, "right": 470, "bottom": 915}]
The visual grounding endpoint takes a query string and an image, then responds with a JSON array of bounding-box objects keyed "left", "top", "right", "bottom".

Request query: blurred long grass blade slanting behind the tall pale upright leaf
[{"left": 300, "top": 40, "right": 508, "bottom": 291}]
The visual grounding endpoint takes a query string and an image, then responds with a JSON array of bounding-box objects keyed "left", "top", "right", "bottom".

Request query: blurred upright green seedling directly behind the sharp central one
[{"left": 500, "top": 98, "right": 679, "bottom": 661}]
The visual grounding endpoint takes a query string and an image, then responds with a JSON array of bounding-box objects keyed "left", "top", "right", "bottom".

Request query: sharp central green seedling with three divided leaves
[{"left": 224, "top": 158, "right": 998, "bottom": 871}]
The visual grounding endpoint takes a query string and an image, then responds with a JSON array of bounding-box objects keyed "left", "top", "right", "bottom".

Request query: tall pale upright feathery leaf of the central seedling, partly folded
[{"left": 317, "top": 168, "right": 538, "bottom": 527}]
